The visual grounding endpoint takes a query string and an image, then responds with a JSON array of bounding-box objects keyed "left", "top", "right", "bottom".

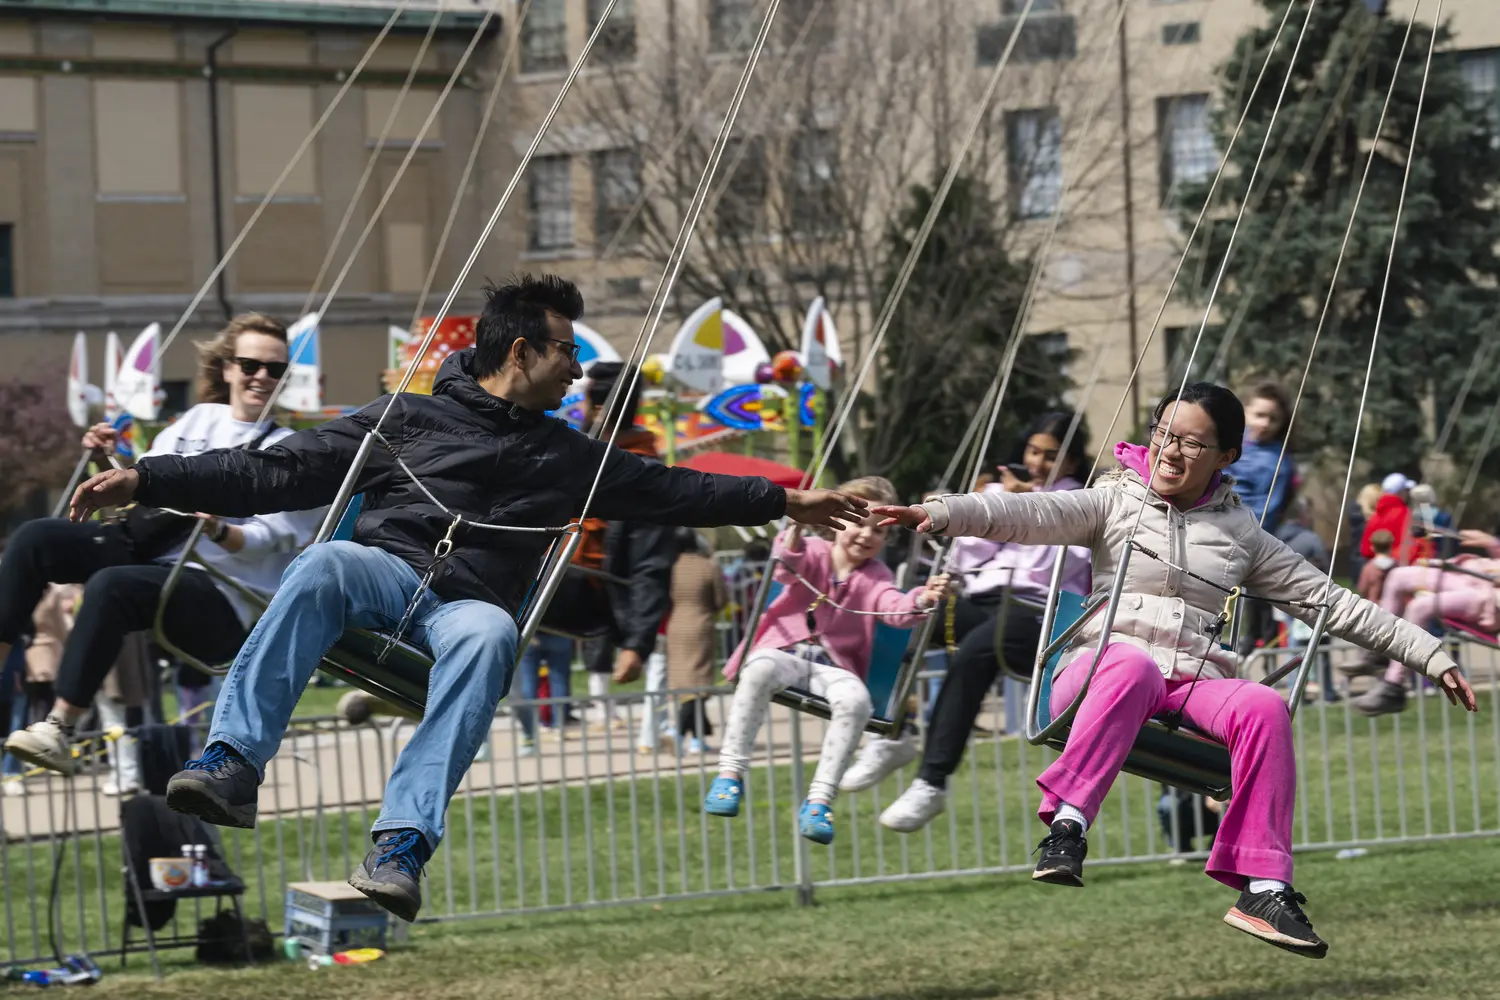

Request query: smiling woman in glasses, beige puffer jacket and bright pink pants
[{"left": 873, "top": 382, "right": 1476, "bottom": 958}]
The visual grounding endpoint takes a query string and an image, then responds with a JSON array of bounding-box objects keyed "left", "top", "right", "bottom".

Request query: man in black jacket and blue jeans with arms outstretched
[{"left": 71, "top": 276, "right": 867, "bottom": 921}]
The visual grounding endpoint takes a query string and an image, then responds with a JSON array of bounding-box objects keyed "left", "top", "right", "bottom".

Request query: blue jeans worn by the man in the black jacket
[{"left": 209, "top": 541, "right": 519, "bottom": 847}]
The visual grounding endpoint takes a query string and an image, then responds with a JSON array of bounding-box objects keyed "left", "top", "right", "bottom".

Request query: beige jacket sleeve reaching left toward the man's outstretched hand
[{"left": 923, "top": 489, "right": 1110, "bottom": 549}]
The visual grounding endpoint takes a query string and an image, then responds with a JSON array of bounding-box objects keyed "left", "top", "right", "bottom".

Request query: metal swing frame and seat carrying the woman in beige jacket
[{"left": 1026, "top": 544, "right": 1329, "bottom": 799}]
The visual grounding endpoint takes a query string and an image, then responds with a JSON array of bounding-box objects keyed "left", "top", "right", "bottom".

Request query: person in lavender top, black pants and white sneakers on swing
[{"left": 840, "top": 412, "right": 1089, "bottom": 834}]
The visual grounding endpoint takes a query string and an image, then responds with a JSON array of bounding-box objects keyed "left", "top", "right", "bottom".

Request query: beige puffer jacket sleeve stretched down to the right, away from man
[{"left": 1245, "top": 532, "right": 1455, "bottom": 678}]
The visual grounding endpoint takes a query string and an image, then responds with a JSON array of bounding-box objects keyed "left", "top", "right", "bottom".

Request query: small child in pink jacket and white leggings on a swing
[{"left": 704, "top": 475, "right": 948, "bottom": 844}]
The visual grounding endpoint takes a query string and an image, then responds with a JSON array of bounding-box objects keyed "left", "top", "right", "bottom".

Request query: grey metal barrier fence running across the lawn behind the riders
[{"left": 0, "top": 649, "right": 1500, "bottom": 963}]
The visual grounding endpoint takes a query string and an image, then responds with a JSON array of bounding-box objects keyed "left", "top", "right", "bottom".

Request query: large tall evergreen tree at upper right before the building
[{"left": 1178, "top": 0, "right": 1500, "bottom": 491}]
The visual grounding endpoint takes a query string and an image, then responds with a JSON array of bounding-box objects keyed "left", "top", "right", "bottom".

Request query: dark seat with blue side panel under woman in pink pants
[{"left": 1037, "top": 591, "right": 1230, "bottom": 799}]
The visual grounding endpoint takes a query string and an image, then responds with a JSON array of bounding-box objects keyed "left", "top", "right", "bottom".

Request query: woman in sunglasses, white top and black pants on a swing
[{"left": 0, "top": 313, "right": 320, "bottom": 774}]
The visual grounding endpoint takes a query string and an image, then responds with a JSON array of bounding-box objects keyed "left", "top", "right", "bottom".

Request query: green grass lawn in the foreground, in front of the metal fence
[{"left": 76, "top": 840, "right": 1500, "bottom": 1000}]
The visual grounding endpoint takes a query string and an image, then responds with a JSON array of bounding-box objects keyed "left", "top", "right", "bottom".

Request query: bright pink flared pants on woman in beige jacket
[{"left": 1037, "top": 643, "right": 1298, "bottom": 889}]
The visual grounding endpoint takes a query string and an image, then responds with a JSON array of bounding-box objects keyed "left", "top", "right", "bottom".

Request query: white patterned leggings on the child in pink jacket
[{"left": 719, "top": 649, "right": 873, "bottom": 802}]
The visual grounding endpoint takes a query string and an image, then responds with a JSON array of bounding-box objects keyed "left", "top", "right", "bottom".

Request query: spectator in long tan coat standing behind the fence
[{"left": 666, "top": 528, "right": 729, "bottom": 754}]
